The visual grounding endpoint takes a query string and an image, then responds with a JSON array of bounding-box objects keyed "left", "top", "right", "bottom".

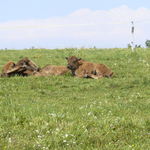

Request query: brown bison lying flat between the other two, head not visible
[{"left": 33, "top": 65, "right": 68, "bottom": 77}]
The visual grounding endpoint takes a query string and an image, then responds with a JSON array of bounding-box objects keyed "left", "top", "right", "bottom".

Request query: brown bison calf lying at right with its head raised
[{"left": 66, "top": 56, "right": 114, "bottom": 79}]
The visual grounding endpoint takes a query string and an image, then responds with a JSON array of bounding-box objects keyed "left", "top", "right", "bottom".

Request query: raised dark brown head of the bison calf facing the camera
[{"left": 66, "top": 56, "right": 81, "bottom": 70}]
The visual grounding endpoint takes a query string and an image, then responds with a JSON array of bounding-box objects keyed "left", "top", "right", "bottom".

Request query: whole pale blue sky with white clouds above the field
[{"left": 0, "top": 0, "right": 150, "bottom": 49}]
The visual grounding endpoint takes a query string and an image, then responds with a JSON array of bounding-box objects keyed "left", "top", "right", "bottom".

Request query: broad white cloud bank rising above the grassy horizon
[{"left": 0, "top": 5, "right": 150, "bottom": 49}]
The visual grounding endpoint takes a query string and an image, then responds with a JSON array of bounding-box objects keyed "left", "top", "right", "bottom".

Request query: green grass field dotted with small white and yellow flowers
[{"left": 0, "top": 48, "right": 150, "bottom": 150}]
